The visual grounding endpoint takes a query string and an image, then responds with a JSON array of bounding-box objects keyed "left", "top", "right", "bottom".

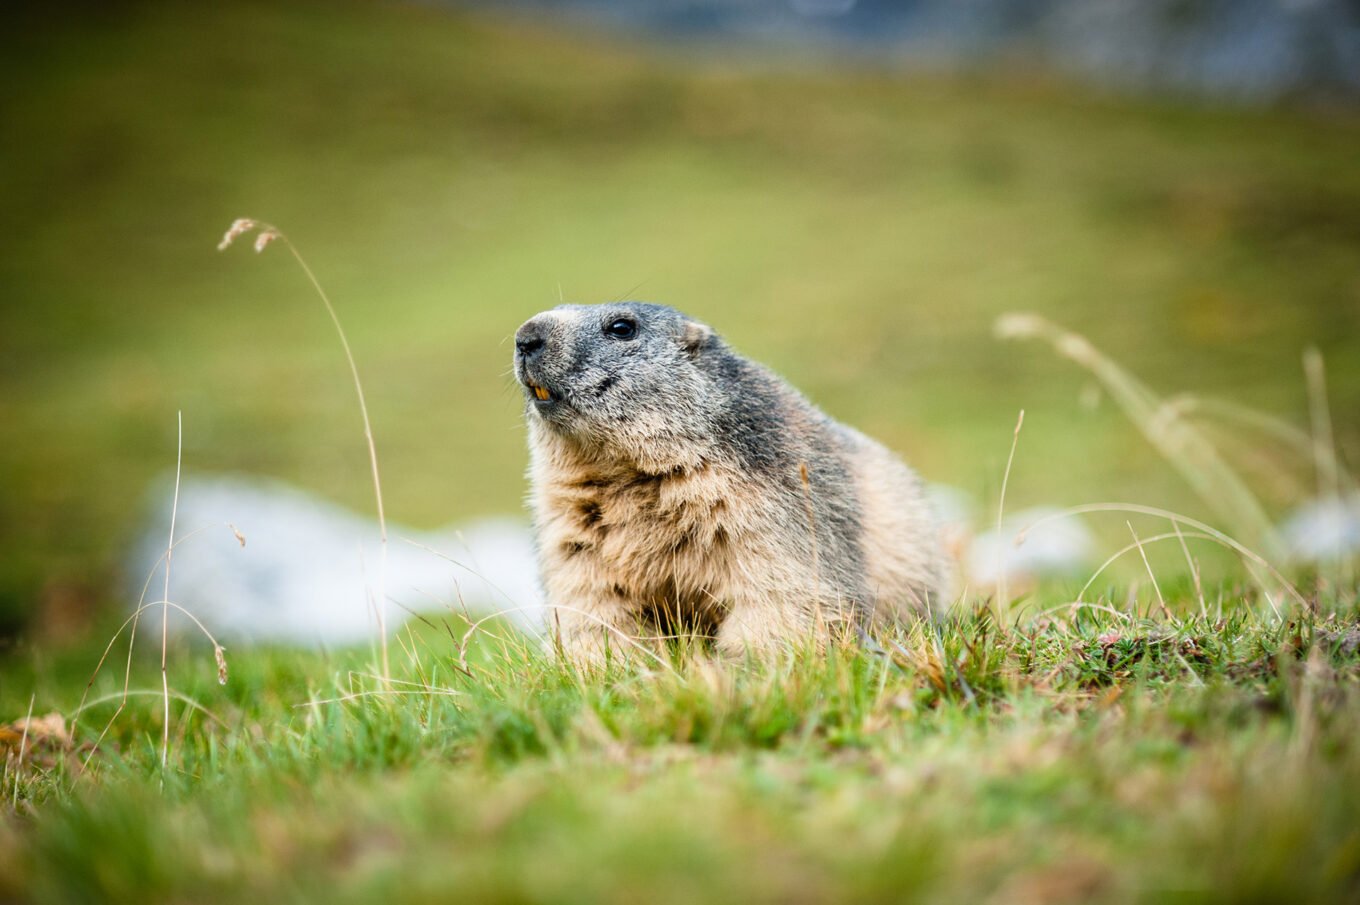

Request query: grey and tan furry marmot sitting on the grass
[{"left": 514, "top": 302, "right": 947, "bottom": 661}]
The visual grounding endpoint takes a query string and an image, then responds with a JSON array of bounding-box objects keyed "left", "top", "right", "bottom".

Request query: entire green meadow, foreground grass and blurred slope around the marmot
[{"left": 0, "top": 3, "right": 1360, "bottom": 902}]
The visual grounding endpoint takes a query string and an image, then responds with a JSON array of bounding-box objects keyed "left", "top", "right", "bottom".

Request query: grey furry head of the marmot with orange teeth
[{"left": 514, "top": 302, "right": 722, "bottom": 472}]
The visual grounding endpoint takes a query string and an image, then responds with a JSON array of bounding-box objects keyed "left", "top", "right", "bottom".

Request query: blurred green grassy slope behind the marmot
[{"left": 0, "top": 1, "right": 1360, "bottom": 631}]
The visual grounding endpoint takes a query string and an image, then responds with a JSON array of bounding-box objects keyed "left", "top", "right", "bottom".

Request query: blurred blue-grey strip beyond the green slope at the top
[{"left": 483, "top": 0, "right": 1360, "bottom": 103}]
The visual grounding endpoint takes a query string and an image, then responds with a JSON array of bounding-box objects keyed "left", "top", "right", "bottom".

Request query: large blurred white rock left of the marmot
[{"left": 128, "top": 476, "right": 543, "bottom": 645}]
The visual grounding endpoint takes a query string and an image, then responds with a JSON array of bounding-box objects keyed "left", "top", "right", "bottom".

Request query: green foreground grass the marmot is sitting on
[{"left": 0, "top": 604, "right": 1360, "bottom": 902}]
